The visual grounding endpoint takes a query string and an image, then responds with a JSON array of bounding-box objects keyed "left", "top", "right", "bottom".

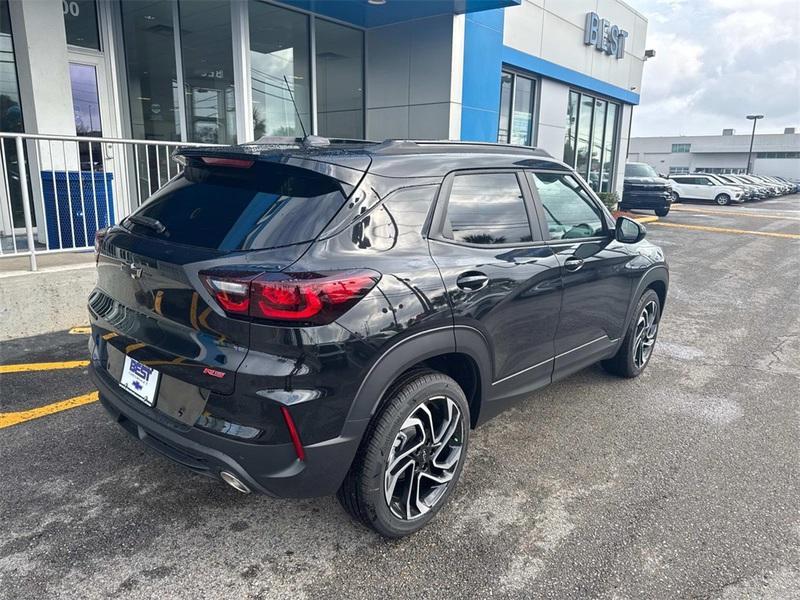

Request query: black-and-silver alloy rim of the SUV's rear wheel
[{"left": 383, "top": 396, "right": 464, "bottom": 521}]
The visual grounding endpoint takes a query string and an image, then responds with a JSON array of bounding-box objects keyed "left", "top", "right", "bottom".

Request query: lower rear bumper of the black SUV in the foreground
[{"left": 89, "top": 365, "right": 366, "bottom": 498}]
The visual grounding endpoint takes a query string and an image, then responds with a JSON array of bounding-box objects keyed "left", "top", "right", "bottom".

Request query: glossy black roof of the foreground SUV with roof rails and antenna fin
[{"left": 176, "top": 136, "right": 570, "bottom": 177}]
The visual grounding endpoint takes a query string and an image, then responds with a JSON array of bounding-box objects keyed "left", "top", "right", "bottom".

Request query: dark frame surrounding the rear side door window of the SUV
[{"left": 427, "top": 168, "right": 545, "bottom": 250}]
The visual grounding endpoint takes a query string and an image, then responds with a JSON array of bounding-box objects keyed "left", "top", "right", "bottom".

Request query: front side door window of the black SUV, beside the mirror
[{"left": 530, "top": 173, "right": 604, "bottom": 240}]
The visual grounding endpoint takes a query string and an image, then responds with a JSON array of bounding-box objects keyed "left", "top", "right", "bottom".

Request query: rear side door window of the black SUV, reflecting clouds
[{"left": 444, "top": 173, "right": 532, "bottom": 245}]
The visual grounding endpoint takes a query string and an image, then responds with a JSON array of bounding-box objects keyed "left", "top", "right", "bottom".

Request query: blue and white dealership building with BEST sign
[{"left": 0, "top": 0, "right": 647, "bottom": 253}]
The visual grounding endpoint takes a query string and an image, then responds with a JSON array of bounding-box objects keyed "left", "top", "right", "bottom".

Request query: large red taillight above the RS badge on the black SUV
[{"left": 201, "top": 270, "right": 380, "bottom": 325}]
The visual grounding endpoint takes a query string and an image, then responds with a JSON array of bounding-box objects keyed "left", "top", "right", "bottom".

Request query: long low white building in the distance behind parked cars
[{"left": 628, "top": 127, "right": 800, "bottom": 181}]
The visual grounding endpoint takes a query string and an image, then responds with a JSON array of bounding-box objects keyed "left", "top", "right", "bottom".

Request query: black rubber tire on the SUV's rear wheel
[{"left": 336, "top": 369, "right": 470, "bottom": 538}]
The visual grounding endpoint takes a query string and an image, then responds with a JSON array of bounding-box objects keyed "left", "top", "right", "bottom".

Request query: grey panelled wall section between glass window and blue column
[{"left": 366, "top": 15, "right": 464, "bottom": 140}]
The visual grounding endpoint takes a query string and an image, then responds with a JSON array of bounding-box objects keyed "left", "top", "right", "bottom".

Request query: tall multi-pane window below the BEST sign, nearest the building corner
[{"left": 564, "top": 91, "right": 620, "bottom": 192}]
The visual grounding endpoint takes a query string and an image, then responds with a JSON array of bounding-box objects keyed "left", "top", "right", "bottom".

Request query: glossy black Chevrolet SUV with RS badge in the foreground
[{"left": 89, "top": 138, "right": 668, "bottom": 537}]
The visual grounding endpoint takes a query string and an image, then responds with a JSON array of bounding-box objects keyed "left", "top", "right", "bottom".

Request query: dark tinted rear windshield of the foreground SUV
[{"left": 123, "top": 162, "right": 345, "bottom": 251}]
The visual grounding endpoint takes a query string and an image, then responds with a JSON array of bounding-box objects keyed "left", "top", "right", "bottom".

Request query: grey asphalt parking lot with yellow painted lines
[{"left": 0, "top": 195, "right": 800, "bottom": 600}]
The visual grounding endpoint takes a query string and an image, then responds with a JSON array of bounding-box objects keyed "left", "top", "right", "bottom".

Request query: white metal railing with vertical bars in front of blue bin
[{"left": 0, "top": 132, "right": 219, "bottom": 271}]
